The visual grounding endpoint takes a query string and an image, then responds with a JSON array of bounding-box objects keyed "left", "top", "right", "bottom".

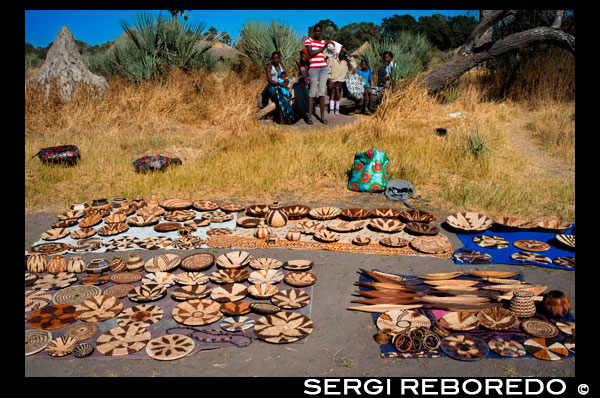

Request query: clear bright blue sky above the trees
[{"left": 25, "top": 10, "right": 478, "bottom": 47}]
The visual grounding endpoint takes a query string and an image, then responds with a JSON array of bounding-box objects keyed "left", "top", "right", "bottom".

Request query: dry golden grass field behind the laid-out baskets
[{"left": 25, "top": 57, "right": 575, "bottom": 221}]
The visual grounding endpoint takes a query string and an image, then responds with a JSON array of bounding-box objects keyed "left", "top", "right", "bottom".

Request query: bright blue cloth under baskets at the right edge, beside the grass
[{"left": 452, "top": 224, "right": 575, "bottom": 271}]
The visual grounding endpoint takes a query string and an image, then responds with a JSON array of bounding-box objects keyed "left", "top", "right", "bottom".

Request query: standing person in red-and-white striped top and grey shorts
[{"left": 304, "top": 24, "right": 333, "bottom": 124}]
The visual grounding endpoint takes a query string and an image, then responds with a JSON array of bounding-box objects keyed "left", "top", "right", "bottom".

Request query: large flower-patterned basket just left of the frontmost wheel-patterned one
[{"left": 96, "top": 326, "right": 152, "bottom": 356}]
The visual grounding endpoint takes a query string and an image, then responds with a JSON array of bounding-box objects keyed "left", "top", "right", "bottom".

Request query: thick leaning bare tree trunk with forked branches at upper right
[{"left": 422, "top": 10, "right": 575, "bottom": 94}]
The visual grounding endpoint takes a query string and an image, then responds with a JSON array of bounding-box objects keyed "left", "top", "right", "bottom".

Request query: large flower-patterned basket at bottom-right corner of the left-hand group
[{"left": 254, "top": 311, "right": 314, "bottom": 344}]
